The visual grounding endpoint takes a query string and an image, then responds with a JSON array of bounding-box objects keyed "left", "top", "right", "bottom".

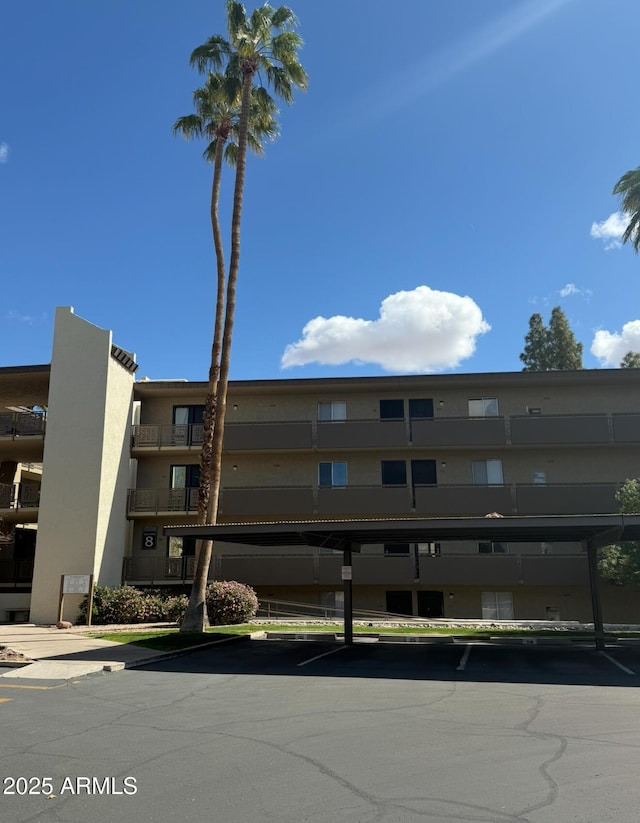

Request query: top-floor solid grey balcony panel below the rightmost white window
[{"left": 411, "top": 417, "right": 507, "bottom": 446}]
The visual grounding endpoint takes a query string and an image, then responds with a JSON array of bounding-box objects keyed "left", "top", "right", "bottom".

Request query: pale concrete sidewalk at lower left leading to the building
[{"left": 0, "top": 624, "right": 183, "bottom": 680}]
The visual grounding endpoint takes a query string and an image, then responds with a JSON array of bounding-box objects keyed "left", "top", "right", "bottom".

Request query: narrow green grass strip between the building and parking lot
[{"left": 93, "top": 623, "right": 640, "bottom": 651}]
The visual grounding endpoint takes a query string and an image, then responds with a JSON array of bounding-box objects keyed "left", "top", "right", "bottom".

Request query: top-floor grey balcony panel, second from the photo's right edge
[{"left": 510, "top": 414, "right": 611, "bottom": 446}]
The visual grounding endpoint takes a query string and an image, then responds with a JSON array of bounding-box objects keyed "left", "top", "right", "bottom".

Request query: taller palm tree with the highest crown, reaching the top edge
[{"left": 182, "top": 0, "right": 307, "bottom": 631}]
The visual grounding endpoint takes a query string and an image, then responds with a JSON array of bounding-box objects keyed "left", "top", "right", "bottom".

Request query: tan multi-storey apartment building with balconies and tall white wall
[{"left": 0, "top": 309, "right": 640, "bottom": 622}]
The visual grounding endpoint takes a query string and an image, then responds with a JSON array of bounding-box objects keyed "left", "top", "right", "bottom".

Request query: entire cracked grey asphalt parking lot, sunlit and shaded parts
[{"left": 0, "top": 641, "right": 640, "bottom": 823}]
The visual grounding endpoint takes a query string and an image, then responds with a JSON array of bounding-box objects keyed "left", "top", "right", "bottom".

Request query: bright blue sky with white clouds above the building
[{"left": 0, "top": 0, "right": 640, "bottom": 380}]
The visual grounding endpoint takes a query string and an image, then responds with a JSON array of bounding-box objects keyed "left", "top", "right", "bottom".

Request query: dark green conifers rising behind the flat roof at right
[{"left": 520, "top": 306, "right": 583, "bottom": 371}]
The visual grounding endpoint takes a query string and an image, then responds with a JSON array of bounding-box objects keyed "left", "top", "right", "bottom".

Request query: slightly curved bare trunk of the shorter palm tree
[{"left": 180, "top": 136, "right": 226, "bottom": 632}]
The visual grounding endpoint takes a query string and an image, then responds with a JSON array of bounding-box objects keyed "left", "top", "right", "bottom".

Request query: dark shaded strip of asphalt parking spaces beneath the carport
[{"left": 136, "top": 640, "right": 640, "bottom": 687}]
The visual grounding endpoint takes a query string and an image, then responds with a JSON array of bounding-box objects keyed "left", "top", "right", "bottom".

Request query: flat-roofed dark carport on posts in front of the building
[{"left": 163, "top": 514, "right": 640, "bottom": 650}]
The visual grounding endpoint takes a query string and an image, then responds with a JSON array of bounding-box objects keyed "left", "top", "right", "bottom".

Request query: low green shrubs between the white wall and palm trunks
[{"left": 77, "top": 586, "right": 188, "bottom": 625}]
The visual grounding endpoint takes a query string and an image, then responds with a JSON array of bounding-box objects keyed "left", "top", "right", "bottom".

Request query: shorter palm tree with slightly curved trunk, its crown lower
[{"left": 173, "top": 72, "right": 278, "bottom": 631}]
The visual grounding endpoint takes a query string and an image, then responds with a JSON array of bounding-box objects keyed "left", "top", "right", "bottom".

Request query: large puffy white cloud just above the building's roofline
[{"left": 281, "top": 286, "right": 491, "bottom": 372}]
